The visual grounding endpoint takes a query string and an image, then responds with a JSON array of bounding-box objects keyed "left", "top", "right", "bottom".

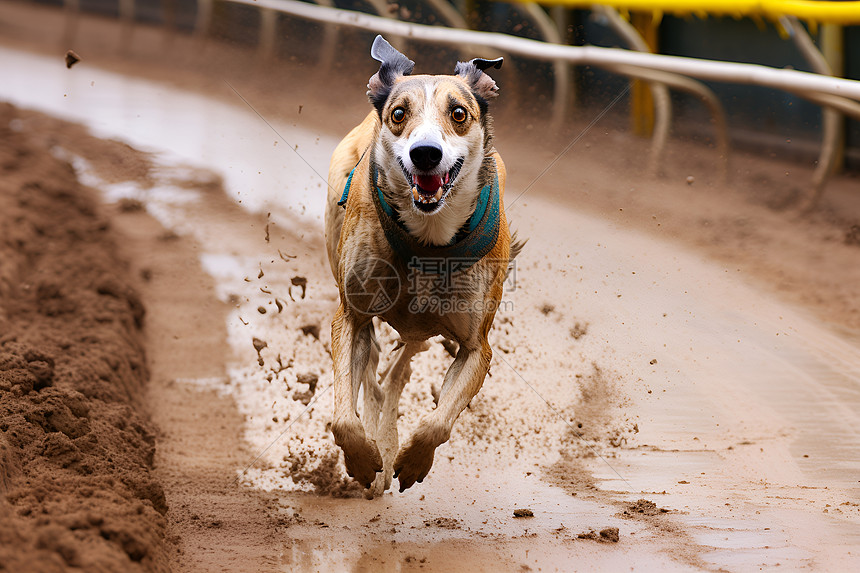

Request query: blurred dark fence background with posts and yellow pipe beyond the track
[{"left": 11, "top": 0, "right": 860, "bottom": 201}]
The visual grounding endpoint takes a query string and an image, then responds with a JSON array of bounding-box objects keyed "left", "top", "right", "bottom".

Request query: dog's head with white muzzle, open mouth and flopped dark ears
[{"left": 367, "top": 36, "right": 502, "bottom": 244}]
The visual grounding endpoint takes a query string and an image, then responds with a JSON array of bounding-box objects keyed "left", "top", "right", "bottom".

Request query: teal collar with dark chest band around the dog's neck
[{"left": 338, "top": 156, "right": 501, "bottom": 274}]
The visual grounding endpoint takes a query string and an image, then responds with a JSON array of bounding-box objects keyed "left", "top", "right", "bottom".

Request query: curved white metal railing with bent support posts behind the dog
[{"left": 60, "top": 0, "right": 860, "bottom": 206}]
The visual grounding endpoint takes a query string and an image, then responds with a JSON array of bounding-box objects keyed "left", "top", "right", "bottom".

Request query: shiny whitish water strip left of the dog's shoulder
[{"left": 0, "top": 47, "right": 338, "bottom": 225}]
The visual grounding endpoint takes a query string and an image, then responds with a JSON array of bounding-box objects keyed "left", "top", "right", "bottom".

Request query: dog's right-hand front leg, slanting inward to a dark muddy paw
[{"left": 394, "top": 340, "right": 493, "bottom": 492}]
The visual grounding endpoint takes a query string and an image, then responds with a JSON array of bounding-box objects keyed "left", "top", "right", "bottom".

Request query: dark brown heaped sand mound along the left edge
[{"left": 0, "top": 105, "right": 167, "bottom": 571}]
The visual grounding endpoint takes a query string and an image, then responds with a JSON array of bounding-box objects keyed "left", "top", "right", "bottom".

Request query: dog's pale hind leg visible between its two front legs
[{"left": 371, "top": 342, "right": 430, "bottom": 495}]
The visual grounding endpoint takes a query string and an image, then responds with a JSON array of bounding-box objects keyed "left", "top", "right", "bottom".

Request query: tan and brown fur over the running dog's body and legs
[{"left": 326, "top": 61, "right": 511, "bottom": 496}]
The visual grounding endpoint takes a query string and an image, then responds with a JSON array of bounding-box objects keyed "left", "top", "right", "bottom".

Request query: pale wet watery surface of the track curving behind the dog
[{"left": 0, "top": 43, "right": 860, "bottom": 571}]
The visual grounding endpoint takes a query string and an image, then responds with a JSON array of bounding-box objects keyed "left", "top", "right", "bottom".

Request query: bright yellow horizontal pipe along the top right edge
[{"left": 498, "top": 0, "right": 860, "bottom": 25}]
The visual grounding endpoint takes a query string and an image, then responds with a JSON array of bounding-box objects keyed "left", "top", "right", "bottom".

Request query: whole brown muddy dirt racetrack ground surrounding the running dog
[{"left": 0, "top": 3, "right": 860, "bottom": 571}]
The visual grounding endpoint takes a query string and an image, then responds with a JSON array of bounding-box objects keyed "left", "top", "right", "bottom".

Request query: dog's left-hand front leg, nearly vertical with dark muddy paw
[{"left": 331, "top": 304, "right": 382, "bottom": 488}]
